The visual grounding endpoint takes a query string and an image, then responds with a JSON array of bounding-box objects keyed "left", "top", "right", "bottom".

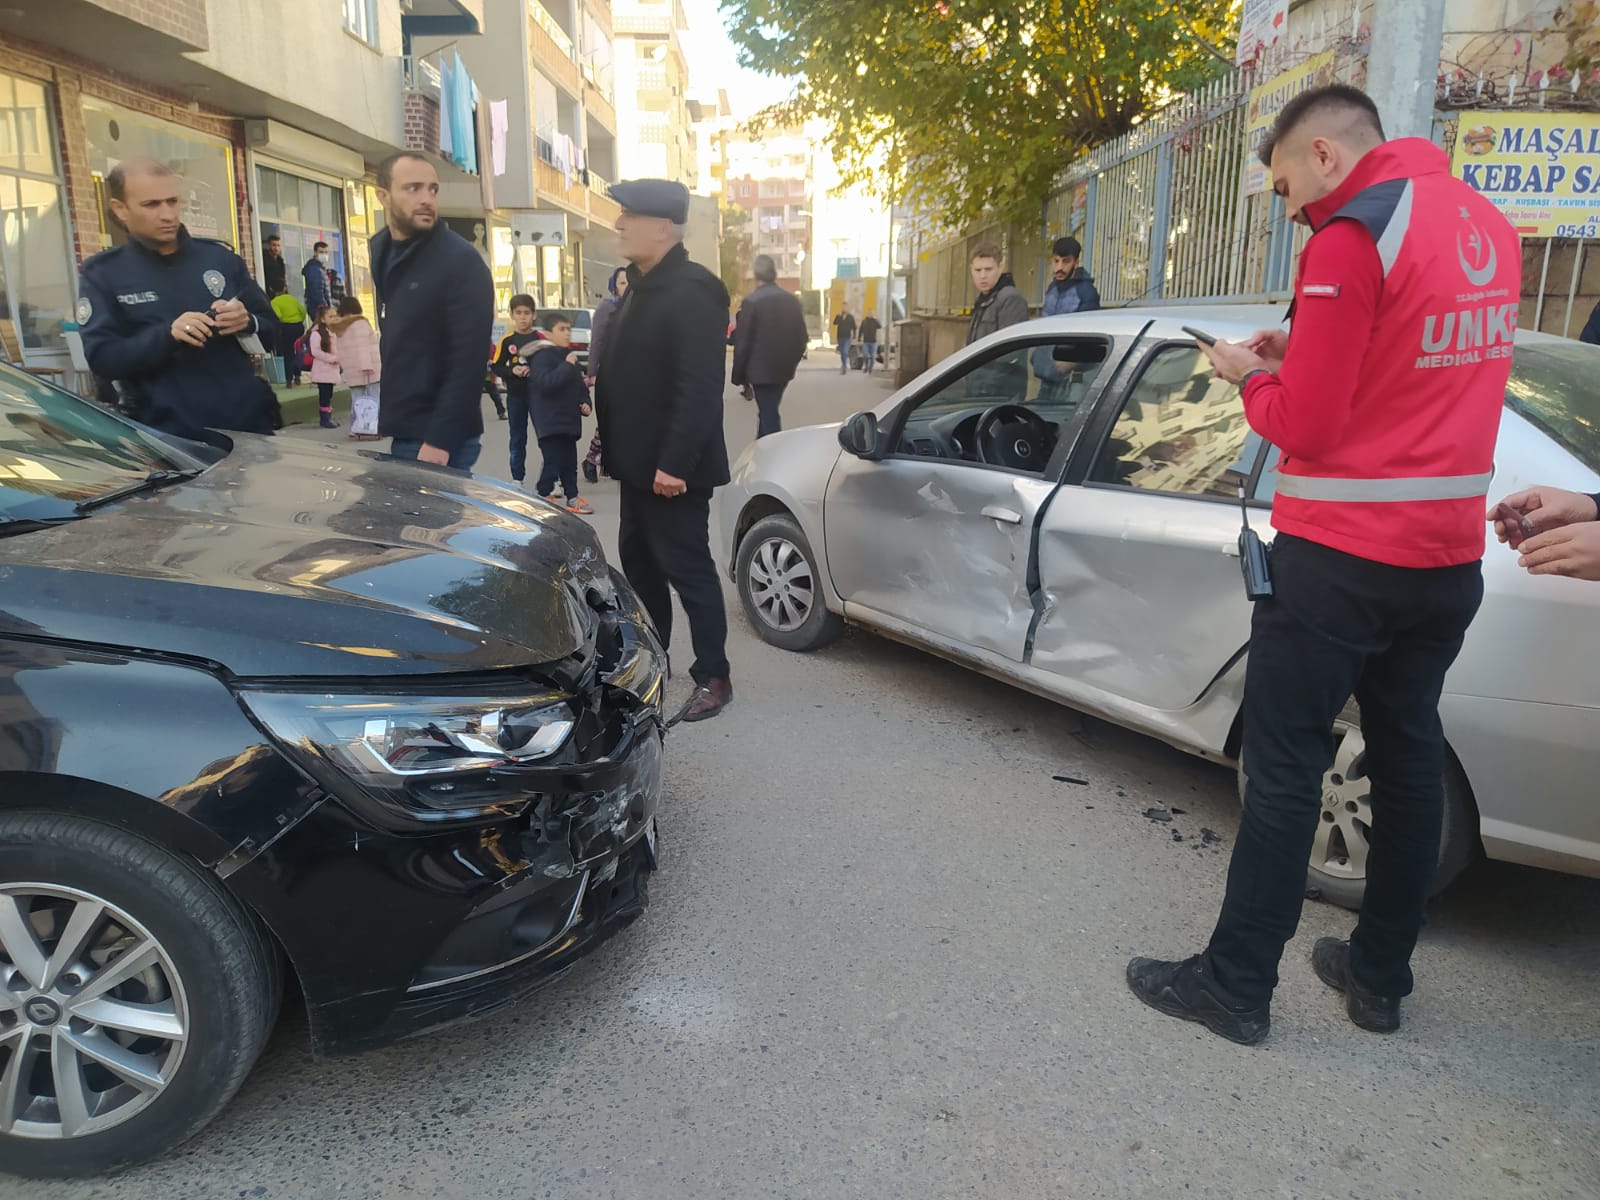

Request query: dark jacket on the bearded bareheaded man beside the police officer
[{"left": 371, "top": 224, "right": 494, "bottom": 453}]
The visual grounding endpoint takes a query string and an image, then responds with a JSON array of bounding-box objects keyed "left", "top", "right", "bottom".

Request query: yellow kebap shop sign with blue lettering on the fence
[{"left": 1450, "top": 112, "right": 1600, "bottom": 238}]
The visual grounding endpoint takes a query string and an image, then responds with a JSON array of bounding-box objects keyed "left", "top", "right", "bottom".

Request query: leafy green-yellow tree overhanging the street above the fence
[{"left": 723, "top": 0, "right": 1238, "bottom": 224}]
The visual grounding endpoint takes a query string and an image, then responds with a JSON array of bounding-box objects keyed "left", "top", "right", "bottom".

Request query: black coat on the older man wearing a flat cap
[{"left": 595, "top": 245, "right": 728, "bottom": 490}]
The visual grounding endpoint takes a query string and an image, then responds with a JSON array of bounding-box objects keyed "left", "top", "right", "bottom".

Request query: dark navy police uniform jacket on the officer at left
[{"left": 77, "top": 227, "right": 278, "bottom": 437}]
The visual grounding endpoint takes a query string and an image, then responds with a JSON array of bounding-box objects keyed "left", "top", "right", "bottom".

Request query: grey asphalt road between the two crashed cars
[{"left": 18, "top": 352, "right": 1600, "bottom": 1200}]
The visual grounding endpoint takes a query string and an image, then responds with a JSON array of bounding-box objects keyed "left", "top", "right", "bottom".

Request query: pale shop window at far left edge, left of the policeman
[{"left": 0, "top": 72, "right": 77, "bottom": 366}]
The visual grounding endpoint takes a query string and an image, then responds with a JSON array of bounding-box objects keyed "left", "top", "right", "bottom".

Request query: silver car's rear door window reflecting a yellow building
[{"left": 1090, "top": 344, "right": 1262, "bottom": 499}]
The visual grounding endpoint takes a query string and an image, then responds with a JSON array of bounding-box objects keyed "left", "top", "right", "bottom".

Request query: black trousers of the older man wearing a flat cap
[{"left": 618, "top": 483, "right": 728, "bottom": 683}]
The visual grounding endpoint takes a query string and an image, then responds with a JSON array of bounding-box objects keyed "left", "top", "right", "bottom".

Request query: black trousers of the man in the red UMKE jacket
[{"left": 1208, "top": 533, "right": 1483, "bottom": 1005}]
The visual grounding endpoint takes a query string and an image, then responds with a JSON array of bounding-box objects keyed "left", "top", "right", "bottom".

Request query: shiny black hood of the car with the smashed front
[{"left": 0, "top": 435, "right": 613, "bottom": 677}]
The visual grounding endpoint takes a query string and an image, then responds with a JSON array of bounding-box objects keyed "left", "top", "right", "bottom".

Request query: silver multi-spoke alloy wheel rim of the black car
[{"left": 0, "top": 883, "right": 189, "bottom": 1139}]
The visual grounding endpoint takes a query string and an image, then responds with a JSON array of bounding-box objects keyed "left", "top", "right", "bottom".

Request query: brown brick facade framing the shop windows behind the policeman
[{"left": 0, "top": 28, "right": 256, "bottom": 275}]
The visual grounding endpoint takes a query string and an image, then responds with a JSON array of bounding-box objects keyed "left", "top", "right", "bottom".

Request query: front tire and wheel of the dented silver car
[{"left": 734, "top": 514, "right": 845, "bottom": 653}]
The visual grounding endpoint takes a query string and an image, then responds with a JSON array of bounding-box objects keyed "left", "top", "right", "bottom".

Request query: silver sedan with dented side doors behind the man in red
[{"left": 718, "top": 306, "right": 1600, "bottom": 907}]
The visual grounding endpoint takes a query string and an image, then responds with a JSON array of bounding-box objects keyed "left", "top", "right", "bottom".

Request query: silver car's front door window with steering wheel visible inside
[{"left": 898, "top": 338, "right": 1110, "bottom": 474}]
